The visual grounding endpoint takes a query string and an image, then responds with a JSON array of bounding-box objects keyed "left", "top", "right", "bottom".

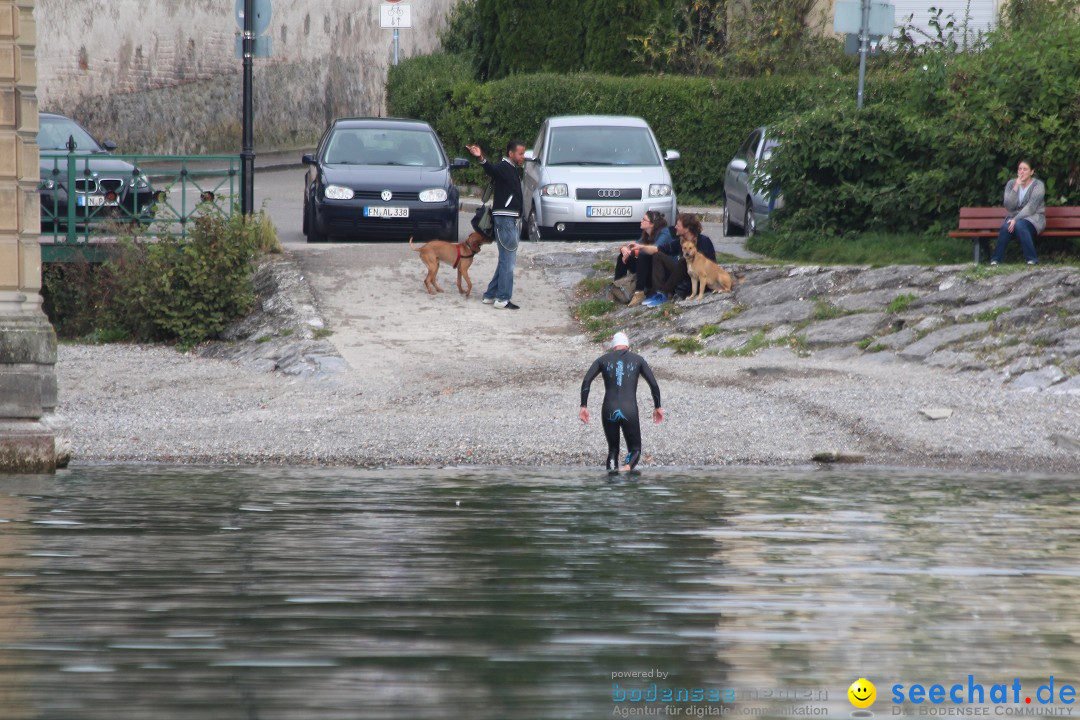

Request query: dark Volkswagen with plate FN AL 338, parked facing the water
[{"left": 303, "top": 118, "right": 469, "bottom": 242}]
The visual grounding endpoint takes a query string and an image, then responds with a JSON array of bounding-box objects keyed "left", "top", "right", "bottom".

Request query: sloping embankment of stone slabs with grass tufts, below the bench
[{"left": 549, "top": 250, "right": 1080, "bottom": 395}]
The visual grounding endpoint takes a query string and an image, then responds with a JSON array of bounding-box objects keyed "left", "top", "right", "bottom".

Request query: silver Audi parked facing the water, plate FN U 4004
[{"left": 522, "top": 116, "right": 679, "bottom": 240}]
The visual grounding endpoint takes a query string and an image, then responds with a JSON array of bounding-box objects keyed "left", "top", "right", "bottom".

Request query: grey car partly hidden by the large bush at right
[{"left": 724, "top": 127, "right": 784, "bottom": 235}]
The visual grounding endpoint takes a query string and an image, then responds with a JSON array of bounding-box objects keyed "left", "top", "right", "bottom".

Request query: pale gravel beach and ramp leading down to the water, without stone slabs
[{"left": 56, "top": 243, "right": 1080, "bottom": 474}]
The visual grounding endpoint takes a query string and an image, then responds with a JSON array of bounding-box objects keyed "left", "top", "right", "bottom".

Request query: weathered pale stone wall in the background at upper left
[{"left": 35, "top": 0, "right": 458, "bottom": 153}]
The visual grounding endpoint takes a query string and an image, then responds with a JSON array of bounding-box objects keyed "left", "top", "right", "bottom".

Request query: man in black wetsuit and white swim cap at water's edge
[{"left": 578, "top": 332, "right": 664, "bottom": 472}]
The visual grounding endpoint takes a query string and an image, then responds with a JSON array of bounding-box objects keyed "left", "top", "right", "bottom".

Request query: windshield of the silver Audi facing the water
[{"left": 548, "top": 126, "right": 660, "bottom": 166}]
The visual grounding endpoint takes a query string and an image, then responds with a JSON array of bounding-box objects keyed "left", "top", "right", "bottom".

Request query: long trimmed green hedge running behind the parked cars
[{"left": 387, "top": 54, "right": 906, "bottom": 202}]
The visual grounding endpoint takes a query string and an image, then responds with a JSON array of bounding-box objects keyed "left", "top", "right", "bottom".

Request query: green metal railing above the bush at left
[{"left": 39, "top": 152, "right": 240, "bottom": 262}]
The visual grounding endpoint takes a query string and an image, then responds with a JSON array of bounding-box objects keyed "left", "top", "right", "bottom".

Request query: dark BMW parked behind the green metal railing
[{"left": 38, "top": 112, "right": 154, "bottom": 226}]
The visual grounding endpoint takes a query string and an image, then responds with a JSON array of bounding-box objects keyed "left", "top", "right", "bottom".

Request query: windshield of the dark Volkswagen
[{"left": 323, "top": 127, "right": 446, "bottom": 167}]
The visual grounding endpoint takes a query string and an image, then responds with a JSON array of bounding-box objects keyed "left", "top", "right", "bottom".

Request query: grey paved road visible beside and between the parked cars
[{"left": 255, "top": 167, "right": 756, "bottom": 258}]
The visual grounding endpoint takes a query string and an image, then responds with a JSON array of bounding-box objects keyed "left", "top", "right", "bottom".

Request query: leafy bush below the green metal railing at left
[{"left": 43, "top": 213, "right": 267, "bottom": 347}]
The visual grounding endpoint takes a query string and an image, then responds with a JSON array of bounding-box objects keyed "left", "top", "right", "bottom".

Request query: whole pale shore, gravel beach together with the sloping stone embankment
[{"left": 57, "top": 243, "right": 1080, "bottom": 474}]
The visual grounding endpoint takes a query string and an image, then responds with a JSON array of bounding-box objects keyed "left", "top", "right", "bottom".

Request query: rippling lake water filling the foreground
[{"left": 0, "top": 466, "right": 1080, "bottom": 720}]
